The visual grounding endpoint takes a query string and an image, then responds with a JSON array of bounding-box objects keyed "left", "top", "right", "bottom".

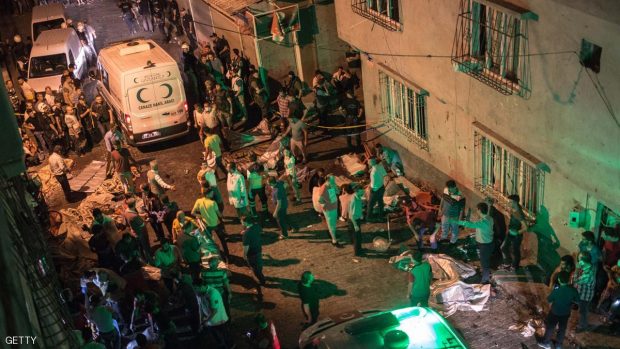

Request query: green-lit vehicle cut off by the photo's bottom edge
[{"left": 299, "top": 307, "right": 469, "bottom": 349}]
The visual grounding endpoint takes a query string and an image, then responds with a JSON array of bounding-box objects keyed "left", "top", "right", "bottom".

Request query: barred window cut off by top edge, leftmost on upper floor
[{"left": 351, "top": 0, "right": 401, "bottom": 31}]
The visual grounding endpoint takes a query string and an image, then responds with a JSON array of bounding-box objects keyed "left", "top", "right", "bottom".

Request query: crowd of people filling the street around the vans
[{"left": 5, "top": 0, "right": 620, "bottom": 349}]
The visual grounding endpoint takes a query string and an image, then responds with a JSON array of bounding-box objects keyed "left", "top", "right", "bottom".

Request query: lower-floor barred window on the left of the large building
[{"left": 379, "top": 71, "right": 428, "bottom": 150}]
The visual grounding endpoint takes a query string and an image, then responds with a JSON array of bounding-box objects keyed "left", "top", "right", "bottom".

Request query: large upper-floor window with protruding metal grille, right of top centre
[{"left": 452, "top": 0, "right": 537, "bottom": 98}]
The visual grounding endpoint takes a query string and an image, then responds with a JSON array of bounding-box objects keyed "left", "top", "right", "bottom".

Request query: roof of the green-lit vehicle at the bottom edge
[{"left": 302, "top": 307, "right": 467, "bottom": 349}]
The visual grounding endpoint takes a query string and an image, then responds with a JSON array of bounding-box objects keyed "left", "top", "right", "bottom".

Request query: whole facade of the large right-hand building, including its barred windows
[{"left": 336, "top": 0, "right": 620, "bottom": 266}]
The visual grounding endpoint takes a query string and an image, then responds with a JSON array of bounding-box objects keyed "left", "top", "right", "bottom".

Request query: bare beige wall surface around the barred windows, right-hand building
[{"left": 336, "top": 0, "right": 620, "bottom": 253}]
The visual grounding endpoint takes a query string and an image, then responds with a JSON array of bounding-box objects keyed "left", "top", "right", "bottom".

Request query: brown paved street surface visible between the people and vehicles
[{"left": 9, "top": 0, "right": 620, "bottom": 349}]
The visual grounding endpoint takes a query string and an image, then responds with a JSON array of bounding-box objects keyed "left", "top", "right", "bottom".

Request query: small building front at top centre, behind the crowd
[{"left": 189, "top": 0, "right": 348, "bottom": 81}]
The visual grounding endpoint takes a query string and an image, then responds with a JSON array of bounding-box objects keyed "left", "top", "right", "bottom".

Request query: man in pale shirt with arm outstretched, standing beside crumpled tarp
[{"left": 454, "top": 202, "right": 493, "bottom": 284}]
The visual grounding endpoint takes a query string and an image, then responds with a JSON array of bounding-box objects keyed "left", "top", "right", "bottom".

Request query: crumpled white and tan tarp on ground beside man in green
[{"left": 389, "top": 251, "right": 491, "bottom": 317}]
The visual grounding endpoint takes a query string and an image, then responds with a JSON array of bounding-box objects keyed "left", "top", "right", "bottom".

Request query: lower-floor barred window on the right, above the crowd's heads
[{"left": 474, "top": 131, "right": 545, "bottom": 217}]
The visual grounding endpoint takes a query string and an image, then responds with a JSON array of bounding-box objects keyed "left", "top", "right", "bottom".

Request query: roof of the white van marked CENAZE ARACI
[{"left": 99, "top": 39, "right": 177, "bottom": 72}]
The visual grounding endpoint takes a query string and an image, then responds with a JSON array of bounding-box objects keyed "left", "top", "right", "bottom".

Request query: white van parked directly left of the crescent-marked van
[{"left": 28, "top": 28, "right": 88, "bottom": 92}]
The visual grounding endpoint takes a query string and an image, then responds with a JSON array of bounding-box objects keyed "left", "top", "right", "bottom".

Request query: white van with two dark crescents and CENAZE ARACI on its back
[{"left": 98, "top": 39, "right": 189, "bottom": 145}]
